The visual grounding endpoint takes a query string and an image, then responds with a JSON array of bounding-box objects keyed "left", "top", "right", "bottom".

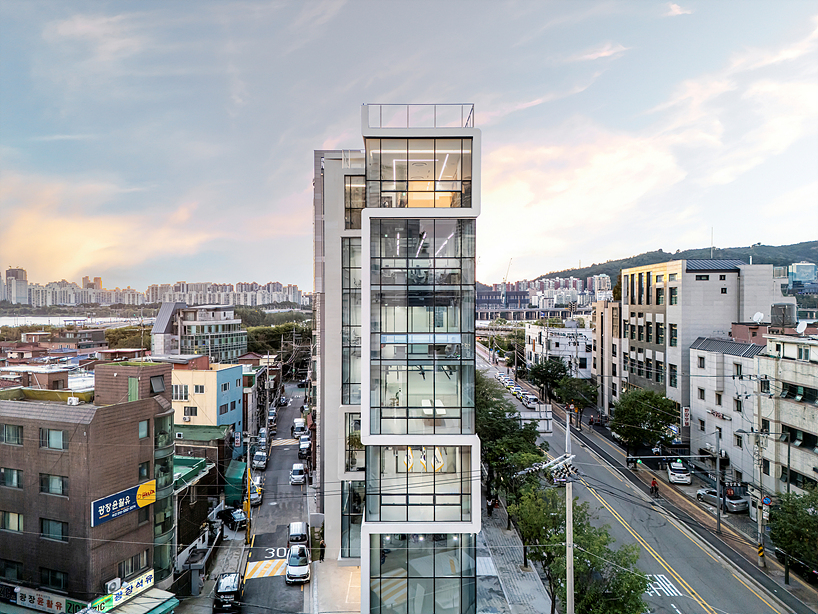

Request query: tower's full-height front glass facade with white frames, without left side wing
[{"left": 361, "top": 119, "right": 480, "bottom": 614}]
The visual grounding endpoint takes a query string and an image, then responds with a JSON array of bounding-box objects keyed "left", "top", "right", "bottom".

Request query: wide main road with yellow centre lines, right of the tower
[{"left": 479, "top": 354, "right": 787, "bottom": 614}]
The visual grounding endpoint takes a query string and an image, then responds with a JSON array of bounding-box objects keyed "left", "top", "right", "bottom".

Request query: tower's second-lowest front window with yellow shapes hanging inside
[{"left": 366, "top": 446, "right": 471, "bottom": 522}]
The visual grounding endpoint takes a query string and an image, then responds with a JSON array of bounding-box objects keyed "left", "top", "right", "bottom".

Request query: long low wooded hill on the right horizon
[{"left": 537, "top": 241, "right": 818, "bottom": 280}]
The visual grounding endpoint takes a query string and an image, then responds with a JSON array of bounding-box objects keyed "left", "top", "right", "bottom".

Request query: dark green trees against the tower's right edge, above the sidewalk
[{"left": 474, "top": 371, "right": 548, "bottom": 493}]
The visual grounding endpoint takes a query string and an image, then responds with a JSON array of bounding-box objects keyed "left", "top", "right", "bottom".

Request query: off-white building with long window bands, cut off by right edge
[{"left": 755, "top": 335, "right": 818, "bottom": 493}]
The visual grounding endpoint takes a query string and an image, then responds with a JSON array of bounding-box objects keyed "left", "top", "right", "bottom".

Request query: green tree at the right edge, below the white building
[{"left": 770, "top": 488, "right": 818, "bottom": 584}]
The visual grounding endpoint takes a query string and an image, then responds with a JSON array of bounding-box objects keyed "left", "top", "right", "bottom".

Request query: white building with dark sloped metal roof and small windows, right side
[{"left": 690, "top": 337, "right": 766, "bottom": 483}]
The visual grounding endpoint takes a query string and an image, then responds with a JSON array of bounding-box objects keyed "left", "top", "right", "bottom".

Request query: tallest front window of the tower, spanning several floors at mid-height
[{"left": 370, "top": 219, "right": 475, "bottom": 434}]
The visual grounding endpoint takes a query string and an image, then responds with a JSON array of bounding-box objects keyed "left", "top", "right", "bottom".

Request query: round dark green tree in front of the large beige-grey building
[{"left": 611, "top": 390, "right": 678, "bottom": 454}]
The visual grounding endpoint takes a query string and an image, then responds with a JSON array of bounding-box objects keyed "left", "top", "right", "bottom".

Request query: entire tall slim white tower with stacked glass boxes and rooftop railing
[{"left": 313, "top": 105, "right": 481, "bottom": 614}]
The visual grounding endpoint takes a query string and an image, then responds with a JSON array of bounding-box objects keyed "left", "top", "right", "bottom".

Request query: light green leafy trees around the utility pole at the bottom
[{"left": 509, "top": 488, "right": 648, "bottom": 614}]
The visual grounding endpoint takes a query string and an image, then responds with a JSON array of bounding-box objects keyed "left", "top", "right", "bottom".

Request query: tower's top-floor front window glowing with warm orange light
[{"left": 364, "top": 138, "right": 472, "bottom": 209}]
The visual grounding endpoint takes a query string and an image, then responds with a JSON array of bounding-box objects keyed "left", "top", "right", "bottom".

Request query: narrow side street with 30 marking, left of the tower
[{"left": 242, "top": 383, "right": 309, "bottom": 614}]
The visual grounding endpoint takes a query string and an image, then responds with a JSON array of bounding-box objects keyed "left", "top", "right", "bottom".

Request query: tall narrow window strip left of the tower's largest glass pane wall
[{"left": 341, "top": 237, "right": 361, "bottom": 405}]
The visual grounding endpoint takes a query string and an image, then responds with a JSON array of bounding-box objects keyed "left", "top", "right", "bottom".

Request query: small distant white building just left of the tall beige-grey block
[{"left": 525, "top": 320, "right": 594, "bottom": 379}]
